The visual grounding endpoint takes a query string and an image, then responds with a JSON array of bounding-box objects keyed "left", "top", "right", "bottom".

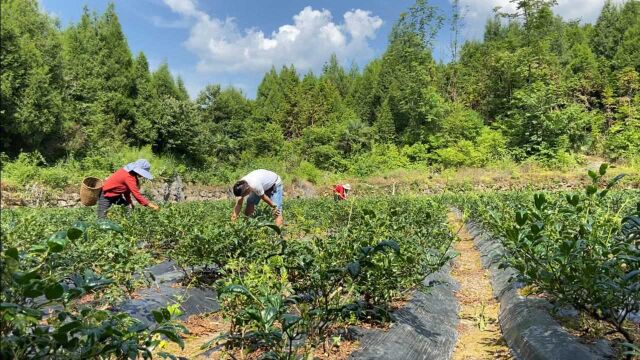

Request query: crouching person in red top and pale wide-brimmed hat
[{"left": 98, "top": 159, "right": 159, "bottom": 219}]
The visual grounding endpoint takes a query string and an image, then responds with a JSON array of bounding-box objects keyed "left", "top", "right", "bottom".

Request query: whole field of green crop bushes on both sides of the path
[{"left": 1, "top": 167, "right": 640, "bottom": 359}]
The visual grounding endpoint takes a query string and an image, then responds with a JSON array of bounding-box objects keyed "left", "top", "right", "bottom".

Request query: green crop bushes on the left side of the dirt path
[{"left": 2, "top": 198, "right": 453, "bottom": 358}]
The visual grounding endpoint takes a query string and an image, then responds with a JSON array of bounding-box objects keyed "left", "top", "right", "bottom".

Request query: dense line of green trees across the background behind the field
[{"left": 0, "top": 0, "right": 640, "bottom": 176}]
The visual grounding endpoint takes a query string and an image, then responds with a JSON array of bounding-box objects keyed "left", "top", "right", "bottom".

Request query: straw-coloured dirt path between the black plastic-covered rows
[{"left": 449, "top": 213, "right": 512, "bottom": 360}]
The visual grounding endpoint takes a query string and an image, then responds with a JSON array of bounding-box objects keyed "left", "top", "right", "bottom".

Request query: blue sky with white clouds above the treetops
[{"left": 40, "top": 0, "right": 616, "bottom": 98}]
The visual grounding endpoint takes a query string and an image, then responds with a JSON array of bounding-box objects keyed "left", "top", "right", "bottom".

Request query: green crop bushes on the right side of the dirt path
[{"left": 458, "top": 166, "right": 640, "bottom": 356}]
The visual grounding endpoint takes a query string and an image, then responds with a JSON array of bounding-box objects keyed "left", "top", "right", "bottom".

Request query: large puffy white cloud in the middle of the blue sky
[{"left": 164, "top": 0, "right": 382, "bottom": 73}]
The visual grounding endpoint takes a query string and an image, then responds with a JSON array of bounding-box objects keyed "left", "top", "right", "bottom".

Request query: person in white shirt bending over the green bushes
[{"left": 231, "top": 169, "right": 284, "bottom": 227}]
